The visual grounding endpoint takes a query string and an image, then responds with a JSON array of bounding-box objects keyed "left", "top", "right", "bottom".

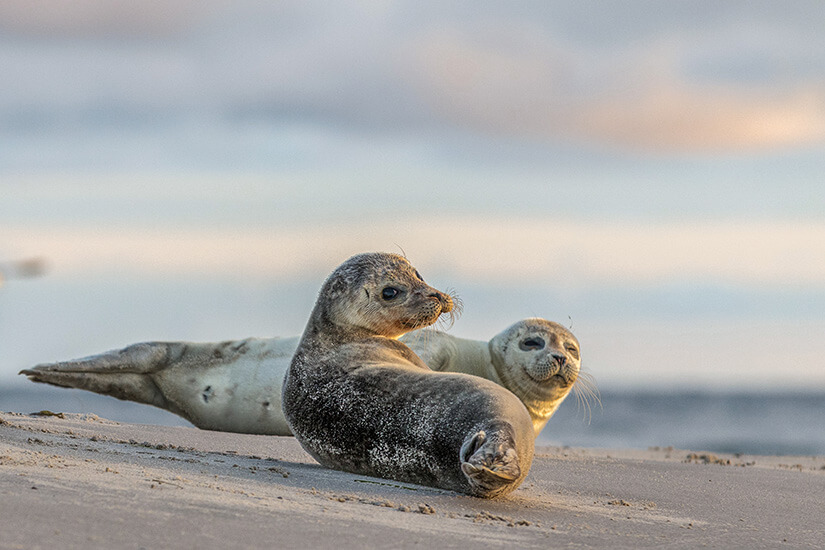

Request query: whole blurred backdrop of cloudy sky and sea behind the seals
[{"left": 0, "top": 0, "right": 825, "bottom": 454}]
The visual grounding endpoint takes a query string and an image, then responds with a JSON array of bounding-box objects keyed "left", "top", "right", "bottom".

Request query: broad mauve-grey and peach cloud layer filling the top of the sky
[{"left": 0, "top": 0, "right": 825, "bottom": 152}]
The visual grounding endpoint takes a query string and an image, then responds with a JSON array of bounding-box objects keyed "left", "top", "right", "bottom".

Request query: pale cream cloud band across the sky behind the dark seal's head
[{"left": 6, "top": 216, "right": 825, "bottom": 289}]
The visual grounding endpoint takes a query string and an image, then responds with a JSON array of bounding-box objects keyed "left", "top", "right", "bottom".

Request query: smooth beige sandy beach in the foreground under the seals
[{"left": 0, "top": 413, "right": 825, "bottom": 549}]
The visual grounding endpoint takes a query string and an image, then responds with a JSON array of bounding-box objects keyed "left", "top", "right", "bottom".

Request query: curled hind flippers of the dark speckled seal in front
[{"left": 461, "top": 430, "right": 521, "bottom": 497}]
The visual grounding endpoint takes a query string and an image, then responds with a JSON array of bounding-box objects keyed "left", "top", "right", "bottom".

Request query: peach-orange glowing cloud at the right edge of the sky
[{"left": 568, "top": 83, "right": 825, "bottom": 152}]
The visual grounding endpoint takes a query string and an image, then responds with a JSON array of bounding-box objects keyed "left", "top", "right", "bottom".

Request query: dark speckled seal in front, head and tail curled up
[{"left": 281, "top": 253, "right": 534, "bottom": 498}]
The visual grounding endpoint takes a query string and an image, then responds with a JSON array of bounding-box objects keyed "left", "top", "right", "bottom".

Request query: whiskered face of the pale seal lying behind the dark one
[{"left": 490, "top": 319, "right": 581, "bottom": 392}]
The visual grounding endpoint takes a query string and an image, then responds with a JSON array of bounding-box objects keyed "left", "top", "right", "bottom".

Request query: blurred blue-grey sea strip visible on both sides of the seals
[{"left": 0, "top": 384, "right": 825, "bottom": 455}]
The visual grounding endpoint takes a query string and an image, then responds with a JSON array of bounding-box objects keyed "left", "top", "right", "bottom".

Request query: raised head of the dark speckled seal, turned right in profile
[{"left": 313, "top": 252, "right": 453, "bottom": 338}]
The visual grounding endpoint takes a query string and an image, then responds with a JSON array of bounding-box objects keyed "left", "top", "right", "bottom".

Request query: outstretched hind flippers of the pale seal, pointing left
[{"left": 20, "top": 343, "right": 169, "bottom": 408}]
